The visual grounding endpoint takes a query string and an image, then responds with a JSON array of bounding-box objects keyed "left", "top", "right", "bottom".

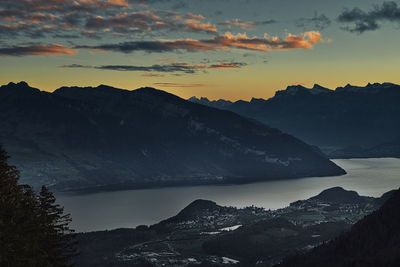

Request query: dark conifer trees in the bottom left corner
[{"left": 0, "top": 146, "right": 76, "bottom": 267}]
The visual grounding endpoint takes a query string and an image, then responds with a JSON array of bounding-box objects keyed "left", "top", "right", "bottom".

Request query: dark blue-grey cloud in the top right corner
[{"left": 338, "top": 1, "right": 400, "bottom": 33}]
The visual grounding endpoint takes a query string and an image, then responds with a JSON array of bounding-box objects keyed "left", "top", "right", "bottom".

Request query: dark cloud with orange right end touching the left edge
[{"left": 0, "top": 44, "right": 75, "bottom": 56}]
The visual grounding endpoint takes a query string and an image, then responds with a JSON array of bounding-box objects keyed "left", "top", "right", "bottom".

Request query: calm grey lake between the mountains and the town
[{"left": 57, "top": 158, "right": 400, "bottom": 232}]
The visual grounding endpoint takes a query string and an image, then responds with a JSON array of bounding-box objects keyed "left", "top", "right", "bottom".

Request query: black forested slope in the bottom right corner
[{"left": 278, "top": 190, "right": 400, "bottom": 267}]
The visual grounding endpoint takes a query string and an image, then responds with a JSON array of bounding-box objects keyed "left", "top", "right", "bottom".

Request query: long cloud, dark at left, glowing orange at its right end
[{"left": 74, "top": 31, "right": 323, "bottom": 53}]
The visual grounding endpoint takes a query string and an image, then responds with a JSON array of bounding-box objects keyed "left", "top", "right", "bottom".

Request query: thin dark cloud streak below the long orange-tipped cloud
[{"left": 60, "top": 62, "right": 247, "bottom": 74}]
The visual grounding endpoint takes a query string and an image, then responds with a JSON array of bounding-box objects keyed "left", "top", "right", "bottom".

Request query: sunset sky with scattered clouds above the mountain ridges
[{"left": 0, "top": 0, "right": 400, "bottom": 100}]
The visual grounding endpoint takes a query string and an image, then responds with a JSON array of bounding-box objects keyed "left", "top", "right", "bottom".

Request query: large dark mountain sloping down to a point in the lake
[{"left": 0, "top": 82, "right": 344, "bottom": 190}]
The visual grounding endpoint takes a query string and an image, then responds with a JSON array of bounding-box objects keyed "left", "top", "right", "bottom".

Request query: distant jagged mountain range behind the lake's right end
[{"left": 189, "top": 83, "right": 400, "bottom": 158}]
